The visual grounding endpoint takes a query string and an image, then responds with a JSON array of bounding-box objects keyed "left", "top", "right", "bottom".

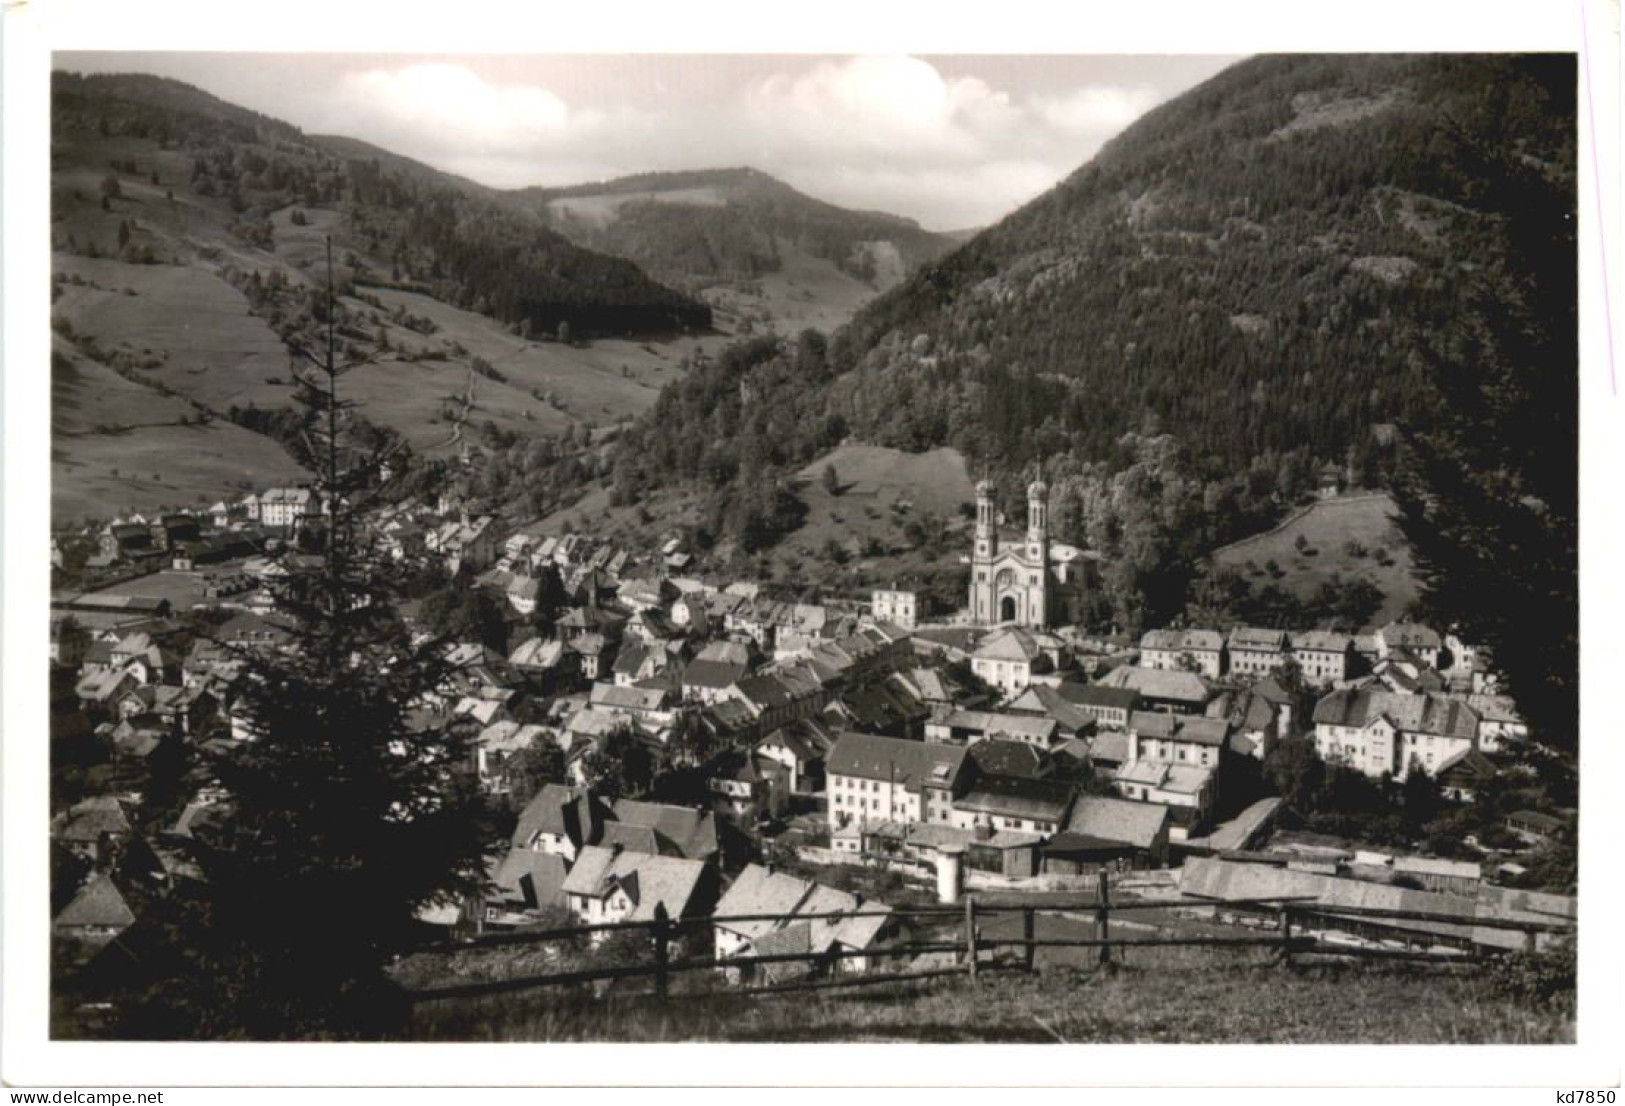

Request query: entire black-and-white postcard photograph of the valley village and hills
[{"left": 5, "top": 0, "right": 1620, "bottom": 1084}]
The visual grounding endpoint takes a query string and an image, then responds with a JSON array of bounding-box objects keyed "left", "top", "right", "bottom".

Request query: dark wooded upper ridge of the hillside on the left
[{"left": 52, "top": 73, "right": 710, "bottom": 336}]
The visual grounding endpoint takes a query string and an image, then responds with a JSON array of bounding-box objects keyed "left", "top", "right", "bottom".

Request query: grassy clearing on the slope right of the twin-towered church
[{"left": 1212, "top": 492, "right": 1417, "bottom": 625}]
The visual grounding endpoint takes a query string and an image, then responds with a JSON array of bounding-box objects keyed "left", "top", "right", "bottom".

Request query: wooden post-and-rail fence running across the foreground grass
[{"left": 396, "top": 872, "right": 1575, "bottom": 1002}]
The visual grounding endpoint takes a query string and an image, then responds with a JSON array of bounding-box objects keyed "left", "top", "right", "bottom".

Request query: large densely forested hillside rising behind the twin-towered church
[{"left": 619, "top": 55, "right": 1575, "bottom": 625}]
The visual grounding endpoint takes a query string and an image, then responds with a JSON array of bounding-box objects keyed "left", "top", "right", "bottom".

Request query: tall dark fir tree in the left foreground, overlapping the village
[{"left": 115, "top": 238, "right": 494, "bottom": 1039}]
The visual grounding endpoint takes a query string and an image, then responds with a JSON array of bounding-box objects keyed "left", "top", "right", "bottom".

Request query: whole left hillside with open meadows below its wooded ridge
[{"left": 52, "top": 73, "right": 723, "bottom": 518}]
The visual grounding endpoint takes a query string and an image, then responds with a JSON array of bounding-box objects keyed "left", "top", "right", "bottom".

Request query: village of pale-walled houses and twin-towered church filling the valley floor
[{"left": 50, "top": 457, "right": 1576, "bottom": 1006}]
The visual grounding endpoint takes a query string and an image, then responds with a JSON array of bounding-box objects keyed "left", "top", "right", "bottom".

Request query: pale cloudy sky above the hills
[{"left": 54, "top": 52, "right": 1238, "bottom": 231}]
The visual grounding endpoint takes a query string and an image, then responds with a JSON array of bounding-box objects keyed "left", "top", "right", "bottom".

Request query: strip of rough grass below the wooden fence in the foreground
[{"left": 413, "top": 950, "right": 1575, "bottom": 1044}]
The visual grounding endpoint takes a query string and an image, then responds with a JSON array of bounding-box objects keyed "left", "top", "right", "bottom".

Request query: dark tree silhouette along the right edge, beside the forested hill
[{"left": 1396, "top": 77, "right": 1580, "bottom": 749}]
